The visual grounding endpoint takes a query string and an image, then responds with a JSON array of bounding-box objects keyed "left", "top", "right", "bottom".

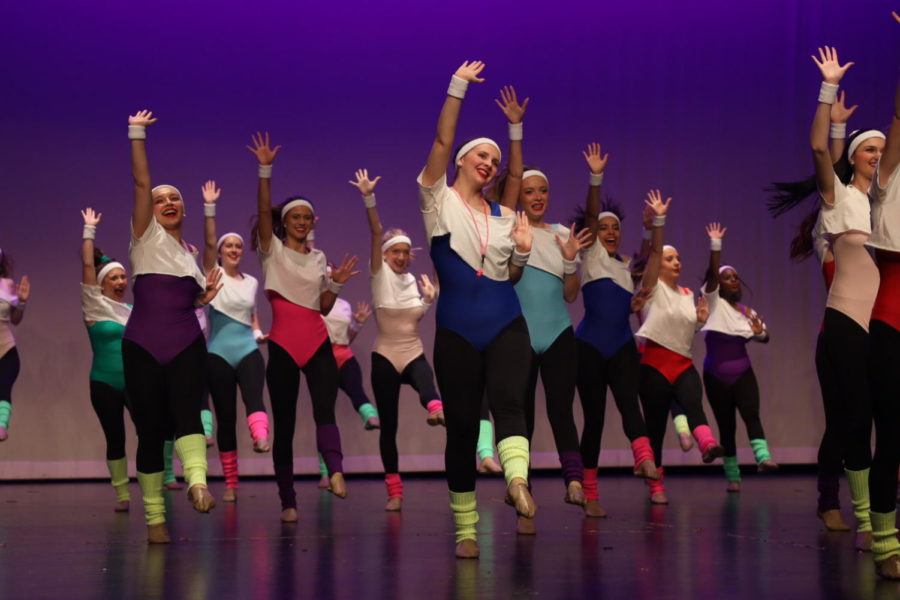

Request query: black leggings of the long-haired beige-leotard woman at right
[{"left": 822, "top": 308, "right": 872, "bottom": 471}]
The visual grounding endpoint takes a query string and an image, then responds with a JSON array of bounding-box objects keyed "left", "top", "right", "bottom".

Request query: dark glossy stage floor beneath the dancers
[{"left": 0, "top": 475, "right": 900, "bottom": 600}]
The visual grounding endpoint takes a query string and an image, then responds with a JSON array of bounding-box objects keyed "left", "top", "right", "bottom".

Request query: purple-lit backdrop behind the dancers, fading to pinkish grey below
[{"left": 0, "top": 0, "right": 900, "bottom": 477}]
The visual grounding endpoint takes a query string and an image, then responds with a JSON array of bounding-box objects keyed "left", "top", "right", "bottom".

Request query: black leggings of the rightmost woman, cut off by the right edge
[{"left": 869, "top": 320, "right": 900, "bottom": 513}]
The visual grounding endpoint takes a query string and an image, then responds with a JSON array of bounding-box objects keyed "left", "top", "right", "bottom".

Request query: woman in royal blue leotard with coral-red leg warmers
[{"left": 575, "top": 143, "right": 659, "bottom": 517}]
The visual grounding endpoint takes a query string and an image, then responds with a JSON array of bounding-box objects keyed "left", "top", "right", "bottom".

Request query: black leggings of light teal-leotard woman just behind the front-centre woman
[{"left": 524, "top": 326, "right": 580, "bottom": 456}]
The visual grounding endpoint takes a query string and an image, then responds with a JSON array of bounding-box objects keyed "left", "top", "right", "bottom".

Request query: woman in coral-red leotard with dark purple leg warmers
[{"left": 247, "top": 133, "right": 358, "bottom": 523}]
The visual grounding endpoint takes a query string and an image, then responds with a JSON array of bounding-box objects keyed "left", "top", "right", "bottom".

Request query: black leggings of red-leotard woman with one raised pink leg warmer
[{"left": 640, "top": 365, "right": 707, "bottom": 466}]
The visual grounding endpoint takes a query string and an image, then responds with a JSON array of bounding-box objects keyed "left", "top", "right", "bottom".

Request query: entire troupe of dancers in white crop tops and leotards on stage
[{"left": 0, "top": 28, "right": 900, "bottom": 578}]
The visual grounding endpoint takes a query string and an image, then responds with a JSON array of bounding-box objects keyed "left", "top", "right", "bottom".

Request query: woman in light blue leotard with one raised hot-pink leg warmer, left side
[{"left": 201, "top": 181, "right": 269, "bottom": 502}]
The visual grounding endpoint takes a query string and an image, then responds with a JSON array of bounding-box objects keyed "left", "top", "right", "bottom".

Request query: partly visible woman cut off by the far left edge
[{"left": 0, "top": 250, "right": 31, "bottom": 442}]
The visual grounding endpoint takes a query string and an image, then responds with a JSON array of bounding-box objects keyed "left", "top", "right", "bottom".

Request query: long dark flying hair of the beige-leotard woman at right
[{"left": 765, "top": 128, "right": 869, "bottom": 261}]
